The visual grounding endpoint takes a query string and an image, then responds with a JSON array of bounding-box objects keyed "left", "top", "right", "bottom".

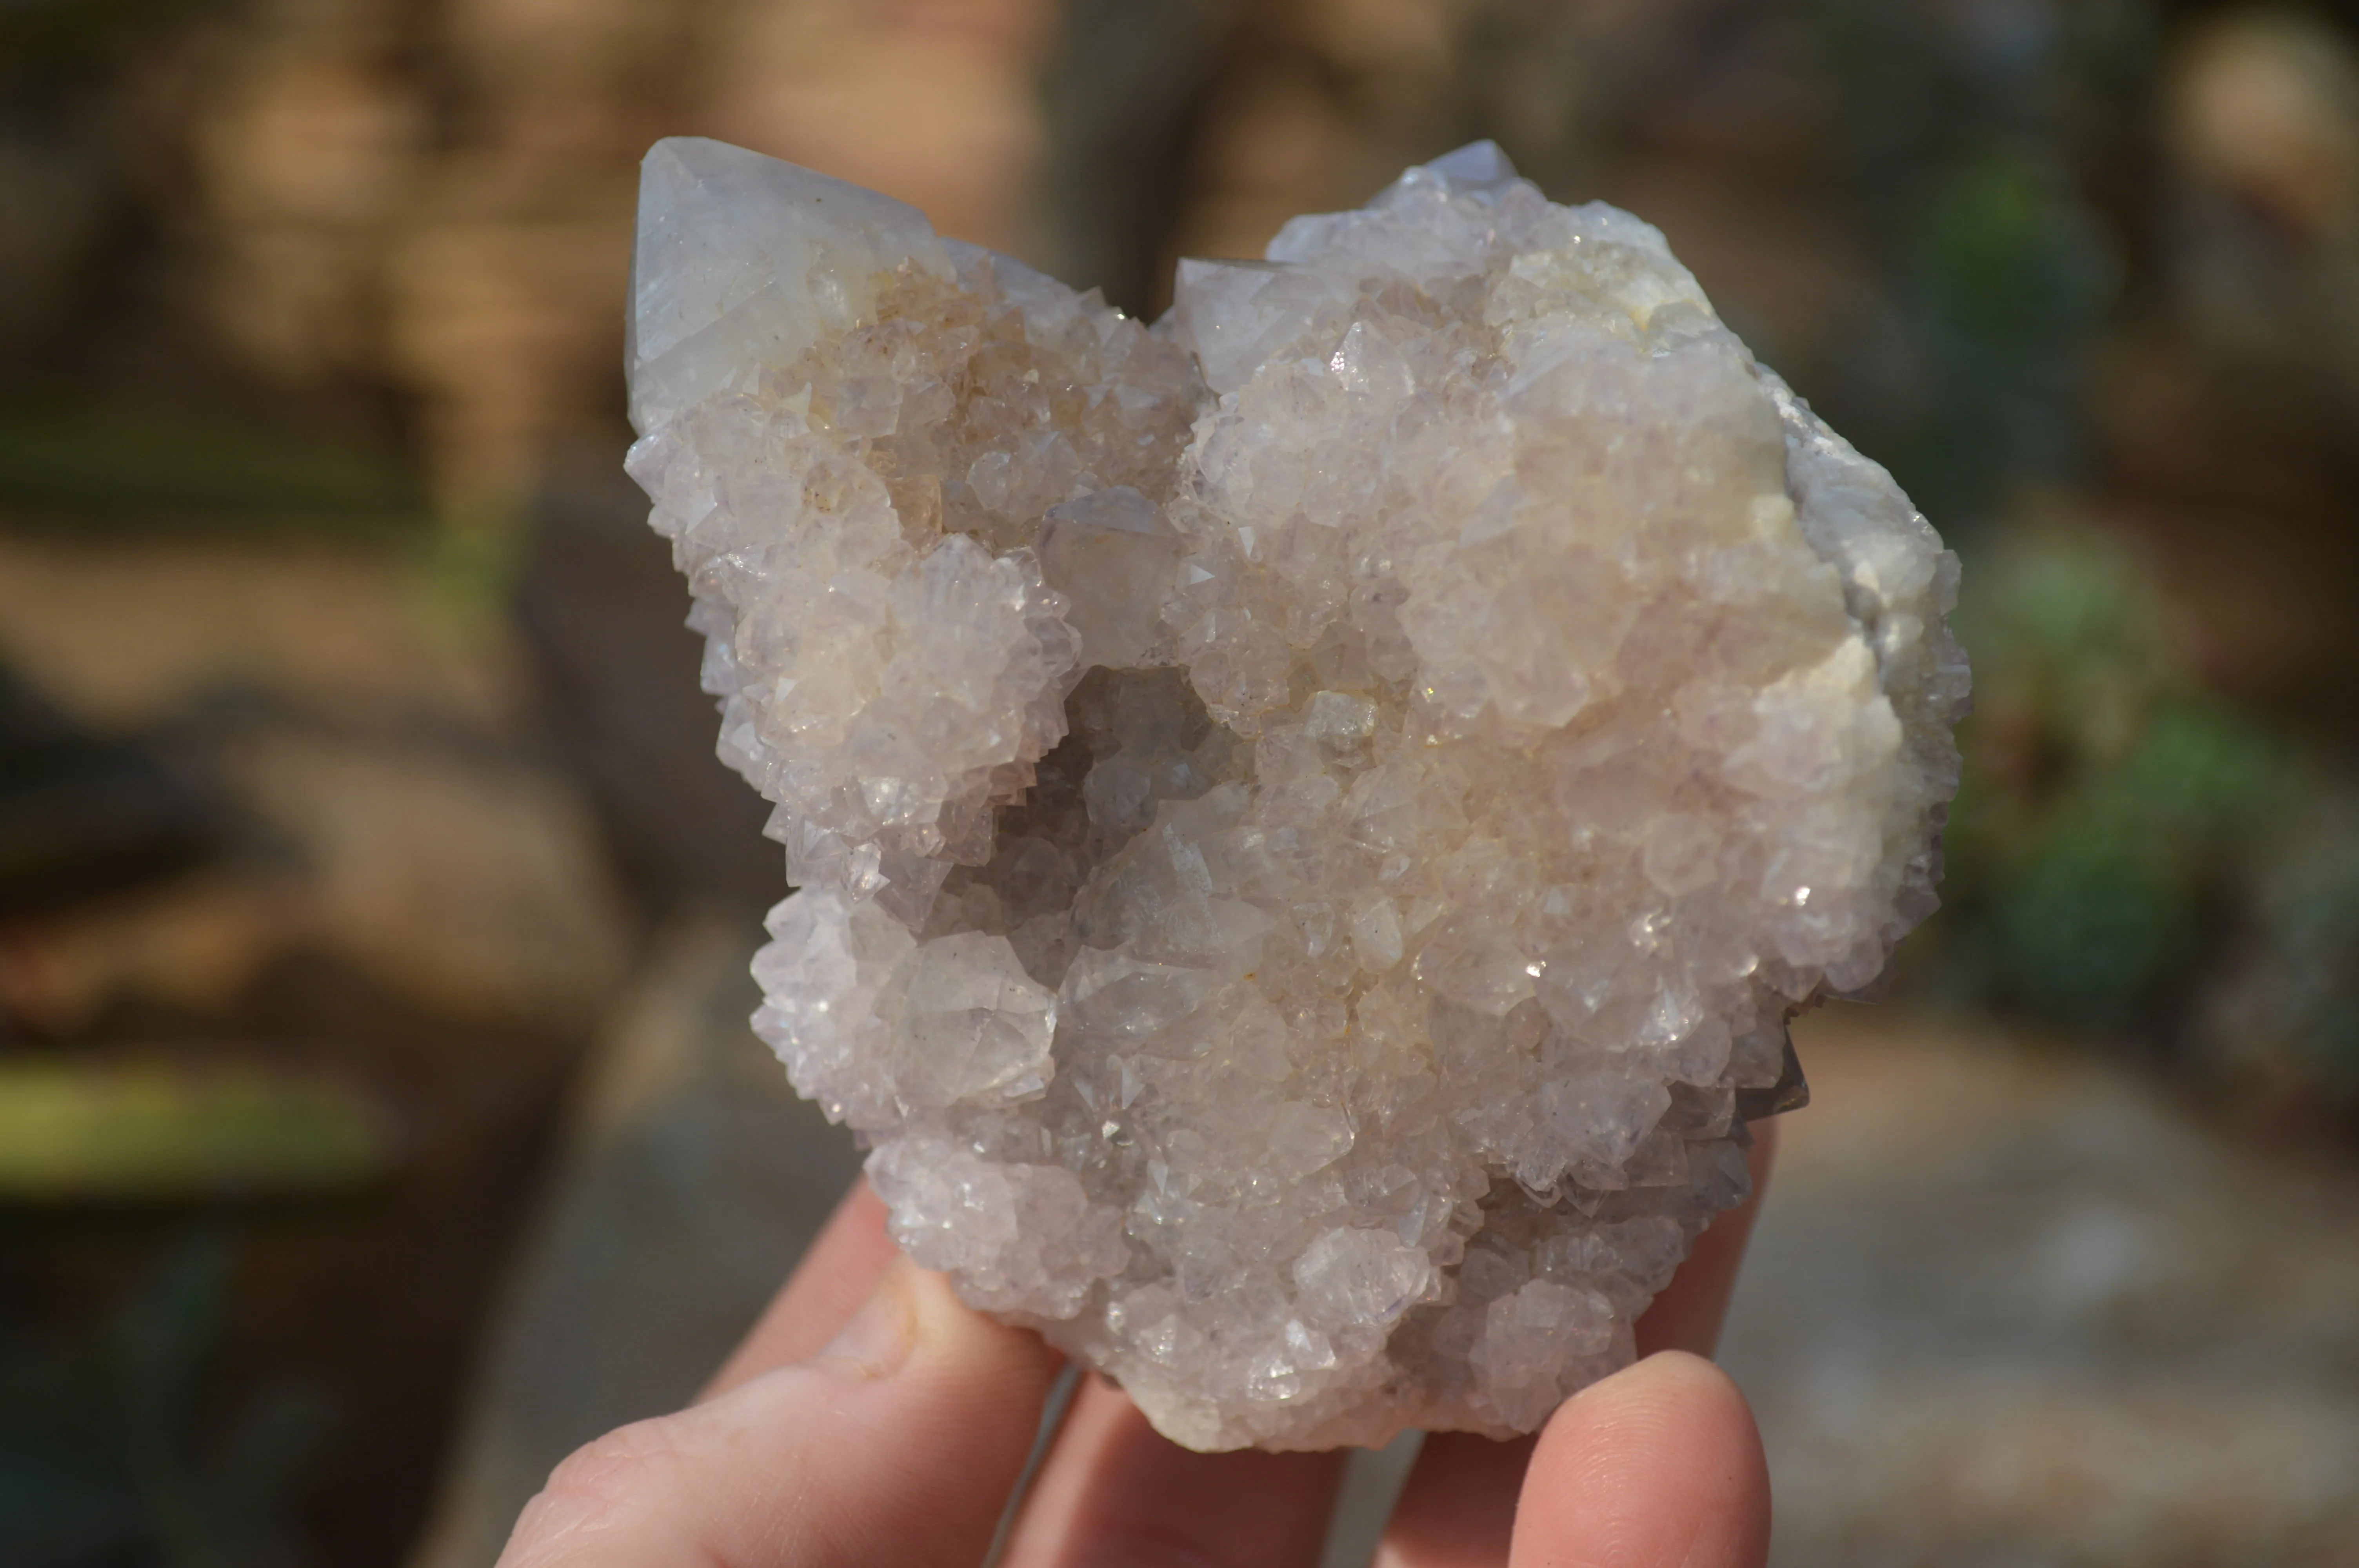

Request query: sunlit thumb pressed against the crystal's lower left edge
[{"left": 500, "top": 1261, "right": 1057, "bottom": 1568}]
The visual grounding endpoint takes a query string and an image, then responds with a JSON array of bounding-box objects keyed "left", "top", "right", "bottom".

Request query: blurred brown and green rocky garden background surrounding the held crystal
[{"left": 0, "top": 0, "right": 2359, "bottom": 1568}]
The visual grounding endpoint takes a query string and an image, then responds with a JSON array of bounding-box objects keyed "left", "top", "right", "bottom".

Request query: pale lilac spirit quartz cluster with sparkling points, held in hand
[{"left": 630, "top": 139, "right": 1967, "bottom": 1448}]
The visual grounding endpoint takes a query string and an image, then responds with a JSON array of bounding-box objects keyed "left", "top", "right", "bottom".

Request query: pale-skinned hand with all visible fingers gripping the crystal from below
[{"left": 500, "top": 1125, "right": 1774, "bottom": 1568}]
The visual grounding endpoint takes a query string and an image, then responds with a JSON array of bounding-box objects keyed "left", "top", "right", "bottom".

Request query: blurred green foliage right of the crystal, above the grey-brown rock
[{"left": 1946, "top": 528, "right": 2359, "bottom": 1061}]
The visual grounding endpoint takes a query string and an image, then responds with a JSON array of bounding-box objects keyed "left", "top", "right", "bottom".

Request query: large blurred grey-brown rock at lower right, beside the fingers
[{"left": 1722, "top": 1007, "right": 2359, "bottom": 1568}]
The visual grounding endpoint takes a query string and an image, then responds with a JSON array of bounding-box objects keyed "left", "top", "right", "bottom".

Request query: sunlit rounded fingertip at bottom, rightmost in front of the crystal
[{"left": 1507, "top": 1351, "right": 1769, "bottom": 1568}]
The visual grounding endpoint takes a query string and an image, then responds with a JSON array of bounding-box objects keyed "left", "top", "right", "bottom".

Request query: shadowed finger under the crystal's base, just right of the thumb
[{"left": 1005, "top": 1377, "right": 1342, "bottom": 1568}]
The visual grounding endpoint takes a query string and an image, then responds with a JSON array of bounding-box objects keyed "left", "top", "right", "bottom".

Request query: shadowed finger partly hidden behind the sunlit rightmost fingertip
[{"left": 1375, "top": 1122, "right": 1776, "bottom": 1568}]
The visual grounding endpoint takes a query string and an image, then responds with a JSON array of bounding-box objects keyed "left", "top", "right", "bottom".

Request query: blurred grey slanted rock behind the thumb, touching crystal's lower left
[{"left": 408, "top": 917, "right": 859, "bottom": 1568}]
